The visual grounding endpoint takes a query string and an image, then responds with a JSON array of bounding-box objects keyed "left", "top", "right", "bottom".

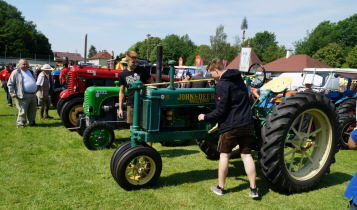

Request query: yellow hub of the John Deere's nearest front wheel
[{"left": 125, "top": 155, "right": 156, "bottom": 185}]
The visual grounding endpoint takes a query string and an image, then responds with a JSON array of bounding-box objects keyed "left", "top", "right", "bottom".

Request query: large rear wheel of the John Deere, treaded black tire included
[{"left": 260, "top": 93, "right": 338, "bottom": 193}]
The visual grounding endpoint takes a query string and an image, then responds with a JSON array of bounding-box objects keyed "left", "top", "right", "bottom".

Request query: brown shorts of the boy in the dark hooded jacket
[{"left": 217, "top": 124, "right": 254, "bottom": 154}]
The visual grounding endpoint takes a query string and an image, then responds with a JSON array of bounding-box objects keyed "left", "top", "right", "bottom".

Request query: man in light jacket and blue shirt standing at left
[{"left": 7, "top": 59, "right": 37, "bottom": 128}]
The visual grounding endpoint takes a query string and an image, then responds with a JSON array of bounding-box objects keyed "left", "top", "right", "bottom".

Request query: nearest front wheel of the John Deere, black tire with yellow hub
[{"left": 113, "top": 146, "right": 162, "bottom": 190}]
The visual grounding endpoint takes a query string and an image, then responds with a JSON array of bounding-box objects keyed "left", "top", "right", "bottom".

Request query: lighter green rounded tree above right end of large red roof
[{"left": 312, "top": 43, "right": 344, "bottom": 68}]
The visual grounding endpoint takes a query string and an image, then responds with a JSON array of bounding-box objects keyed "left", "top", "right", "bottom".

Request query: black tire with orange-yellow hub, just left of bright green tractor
[{"left": 61, "top": 97, "right": 83, "bottom": 131}]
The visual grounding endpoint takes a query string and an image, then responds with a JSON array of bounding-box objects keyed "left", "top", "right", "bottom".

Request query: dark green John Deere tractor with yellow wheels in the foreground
[{"left": 110, "top": 62, "right": 338, "bottom": 193}]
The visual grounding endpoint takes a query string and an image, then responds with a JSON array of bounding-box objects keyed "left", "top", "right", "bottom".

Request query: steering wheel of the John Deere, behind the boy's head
[{"left": 245, "top": 63, "right": 266, "bottom": 88}]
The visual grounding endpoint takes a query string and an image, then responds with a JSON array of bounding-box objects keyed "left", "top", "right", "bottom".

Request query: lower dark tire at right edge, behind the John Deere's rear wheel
[{"left": 338, "top": 114, "right": 356, "bottom": 149}]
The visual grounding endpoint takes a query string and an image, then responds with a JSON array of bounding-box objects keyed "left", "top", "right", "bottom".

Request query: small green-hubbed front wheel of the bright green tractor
[{"left": 83, "top": 122, "right": 115, "bottom": 150}]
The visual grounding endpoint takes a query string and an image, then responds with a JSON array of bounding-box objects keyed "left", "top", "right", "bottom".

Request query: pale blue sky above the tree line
[{"left": 5, "top": 0, "right": 357, "bottom": 55}]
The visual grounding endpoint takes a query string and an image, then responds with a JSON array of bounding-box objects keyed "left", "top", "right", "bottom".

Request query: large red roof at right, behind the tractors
[{"left": 264, "top": 53, "right": 331, "bottom": 76}]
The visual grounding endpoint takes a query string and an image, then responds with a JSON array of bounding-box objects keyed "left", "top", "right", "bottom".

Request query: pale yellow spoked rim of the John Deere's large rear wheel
[{"left": 284, "top": 109, "right": 333, "bottom": 181}]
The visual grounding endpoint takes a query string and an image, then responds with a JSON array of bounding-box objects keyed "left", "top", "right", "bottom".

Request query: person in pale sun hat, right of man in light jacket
[{"left": 36, "top": 64, "right": 53, "bottom": 120}]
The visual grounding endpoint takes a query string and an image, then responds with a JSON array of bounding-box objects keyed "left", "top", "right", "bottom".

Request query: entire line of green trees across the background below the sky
[{"left": 0, "top": 0, "right": 357, "bottom": 68}]
